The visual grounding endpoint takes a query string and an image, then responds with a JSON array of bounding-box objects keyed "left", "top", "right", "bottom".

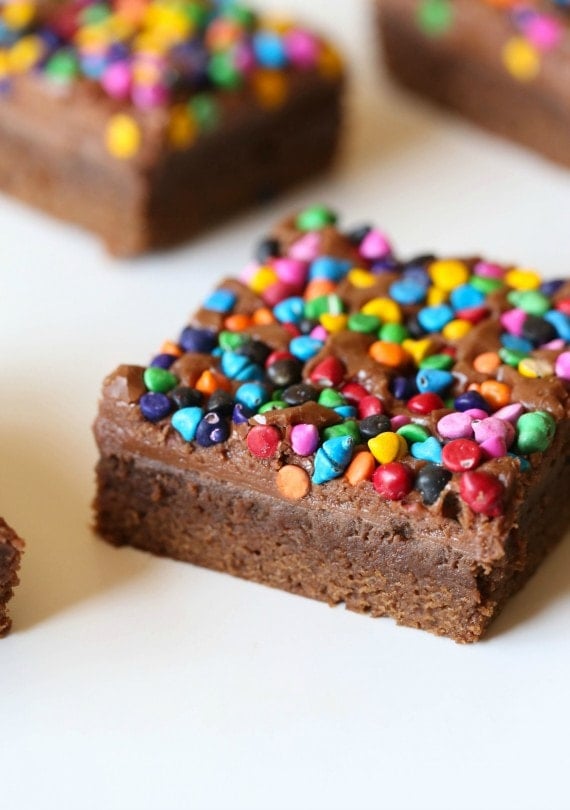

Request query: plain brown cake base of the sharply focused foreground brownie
[{"left": 95, "top": 432, "right": 568, "bottom": 642}]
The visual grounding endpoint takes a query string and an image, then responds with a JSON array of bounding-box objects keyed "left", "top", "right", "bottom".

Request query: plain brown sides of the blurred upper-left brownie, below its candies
[{"left": 0, "top": 80, "right": 342, "bottom": 256}]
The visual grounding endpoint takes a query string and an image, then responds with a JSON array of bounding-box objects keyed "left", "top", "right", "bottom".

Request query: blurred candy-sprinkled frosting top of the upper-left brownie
[{"left": 0, "top": 0, "right": 342, "bottom": 164}]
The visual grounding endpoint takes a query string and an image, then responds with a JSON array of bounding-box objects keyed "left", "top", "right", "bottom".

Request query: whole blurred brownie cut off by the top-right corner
[{"left": 375, "top": 0, "right": 570, "bottom": 166}]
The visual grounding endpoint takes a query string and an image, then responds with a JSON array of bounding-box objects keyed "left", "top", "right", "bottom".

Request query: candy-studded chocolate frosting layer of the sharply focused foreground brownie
[{"left": 97, "top": 206, "right": 570, "bottom": 556}]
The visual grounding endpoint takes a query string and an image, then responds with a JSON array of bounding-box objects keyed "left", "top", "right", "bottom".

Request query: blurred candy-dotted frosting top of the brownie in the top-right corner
[{"left": 392, "top": 0, "right": 570, "bottom": 84}]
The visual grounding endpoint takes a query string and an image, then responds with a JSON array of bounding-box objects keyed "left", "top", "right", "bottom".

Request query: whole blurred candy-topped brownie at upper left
[{"left": 0, "top": 0, "right": 343, "bottom": 256}]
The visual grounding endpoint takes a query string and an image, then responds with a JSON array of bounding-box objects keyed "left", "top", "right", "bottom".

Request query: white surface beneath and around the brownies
[{"left": 0, "top": 0, "right": 570, "bottom": 810}]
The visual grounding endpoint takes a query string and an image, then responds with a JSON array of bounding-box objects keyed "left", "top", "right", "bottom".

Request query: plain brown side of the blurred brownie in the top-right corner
[{"left": 379, "top": 3, "right": 570, "bottom": 166}]
